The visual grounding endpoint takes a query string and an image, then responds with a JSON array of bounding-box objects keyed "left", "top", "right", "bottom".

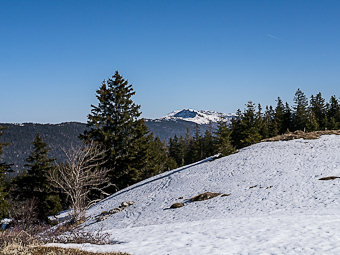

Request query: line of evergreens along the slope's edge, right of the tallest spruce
[{"left": 157, "top": 89, "right": 340, "bottom": 167}]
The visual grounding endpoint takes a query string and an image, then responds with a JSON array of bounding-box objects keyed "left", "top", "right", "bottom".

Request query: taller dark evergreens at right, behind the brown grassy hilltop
[{"left": 230, "top": 89, "right": 340, "bottom": 148}]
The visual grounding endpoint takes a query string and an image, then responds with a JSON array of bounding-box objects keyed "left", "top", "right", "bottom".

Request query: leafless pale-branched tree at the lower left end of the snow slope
[{"left": 48, "top": 143, "right": 110, "bottom": 222}]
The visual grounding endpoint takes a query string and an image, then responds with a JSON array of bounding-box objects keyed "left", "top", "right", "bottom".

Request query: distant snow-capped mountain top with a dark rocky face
[{"left": 159, "top": 109, "right": 235, "bottom": 124}]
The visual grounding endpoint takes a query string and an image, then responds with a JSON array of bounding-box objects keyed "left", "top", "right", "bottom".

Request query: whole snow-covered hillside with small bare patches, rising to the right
[{"left": 53, "top": 135, "right": 340, "bottom": 255}]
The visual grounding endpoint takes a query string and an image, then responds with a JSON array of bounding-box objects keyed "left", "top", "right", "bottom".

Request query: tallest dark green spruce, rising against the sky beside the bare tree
[{"left": 80, "top": 71, "right": 150, "bottom": 190}]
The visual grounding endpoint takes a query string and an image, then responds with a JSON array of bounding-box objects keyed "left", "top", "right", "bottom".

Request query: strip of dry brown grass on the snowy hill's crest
[{"left": 262, "top": 130, "right": 340, "bottom": 142}]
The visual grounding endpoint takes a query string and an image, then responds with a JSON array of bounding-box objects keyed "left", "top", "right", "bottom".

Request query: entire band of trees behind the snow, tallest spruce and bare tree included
[{"left": 0, "top": 72, "right": 340, "bottom": 225}]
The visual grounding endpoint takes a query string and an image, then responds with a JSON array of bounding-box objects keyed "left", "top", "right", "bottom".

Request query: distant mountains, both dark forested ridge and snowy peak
[{"left": 0, "top": 109, "right": 235, "bottom": 171}]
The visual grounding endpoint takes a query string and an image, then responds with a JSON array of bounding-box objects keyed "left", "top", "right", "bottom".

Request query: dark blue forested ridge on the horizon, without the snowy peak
[{"left": 0, "top": 120, "right": 214, "bottom": 171}]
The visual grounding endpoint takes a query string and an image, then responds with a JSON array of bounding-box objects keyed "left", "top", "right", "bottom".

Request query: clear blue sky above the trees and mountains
[{"left": 0, "top": 0, "right": 340, "bottom": 123}]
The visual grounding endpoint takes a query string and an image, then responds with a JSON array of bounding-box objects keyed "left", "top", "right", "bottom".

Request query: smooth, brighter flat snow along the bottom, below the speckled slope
[{"left": 51, "top": 215, "right": 340, "bottom": 255}]
